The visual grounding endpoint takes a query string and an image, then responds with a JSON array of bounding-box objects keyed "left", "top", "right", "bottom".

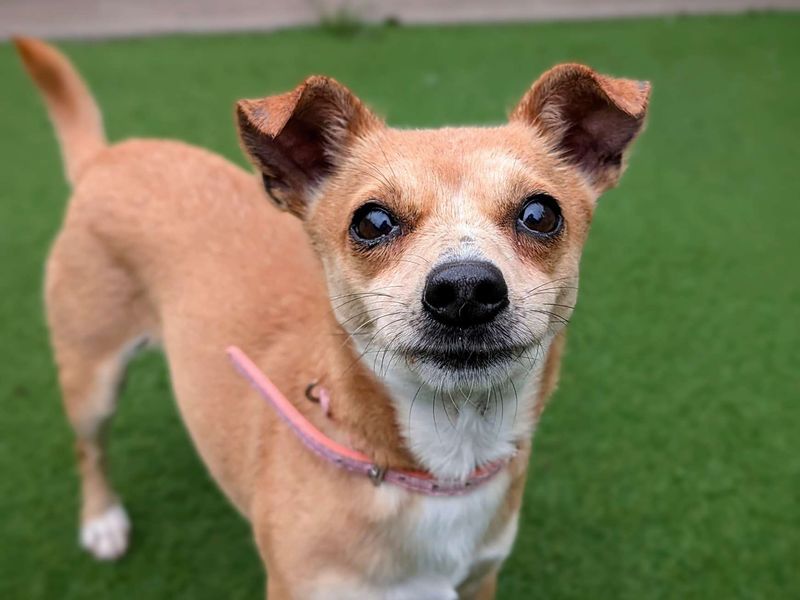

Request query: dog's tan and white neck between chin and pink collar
[{"left": 306, "top": 316, "right": 547, "bottom": 480}]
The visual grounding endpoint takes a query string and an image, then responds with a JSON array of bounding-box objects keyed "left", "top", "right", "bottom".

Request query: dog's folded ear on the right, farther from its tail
[{"left": 511, "top": 64, "right": 650, "bottom": 194}]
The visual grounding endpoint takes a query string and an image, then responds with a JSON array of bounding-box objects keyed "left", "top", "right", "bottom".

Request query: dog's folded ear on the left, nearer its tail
[{"left": 236, "top": 76, "right": 380, "bottom": 218}]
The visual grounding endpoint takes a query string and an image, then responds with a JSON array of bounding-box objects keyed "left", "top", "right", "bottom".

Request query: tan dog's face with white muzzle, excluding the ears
[{"left": 296, "top": 125, "right": 592, "bottom": 389}]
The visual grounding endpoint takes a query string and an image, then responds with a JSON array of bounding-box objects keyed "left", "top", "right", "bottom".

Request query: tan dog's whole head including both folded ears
[{"left": 238, "top": 65, "right": 649, "bottom": 390}]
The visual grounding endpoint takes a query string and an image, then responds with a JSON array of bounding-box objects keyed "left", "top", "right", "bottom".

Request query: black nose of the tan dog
[{"left": 422, "top": 261, "right": 508, "bottom": 327}]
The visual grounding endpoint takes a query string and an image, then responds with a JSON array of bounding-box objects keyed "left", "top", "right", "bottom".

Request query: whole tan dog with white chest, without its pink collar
[{"left": 16, "top": 39, "right": 649, "bottom": 600}]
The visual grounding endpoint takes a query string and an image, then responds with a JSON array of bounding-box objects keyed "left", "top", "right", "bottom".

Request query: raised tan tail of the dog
[{"left": 14, "top": 37, "right": 106, "bottom": 185}]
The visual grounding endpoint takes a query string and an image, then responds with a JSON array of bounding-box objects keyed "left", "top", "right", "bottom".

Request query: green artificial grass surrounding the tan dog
[{"left": 0, "top": 14, "right": 800, "bottom": 600}]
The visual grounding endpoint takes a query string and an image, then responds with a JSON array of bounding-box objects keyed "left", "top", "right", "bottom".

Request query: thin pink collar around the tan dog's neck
[{"left": 228, "top": 346, "right": 510, "bottom": 496}]
